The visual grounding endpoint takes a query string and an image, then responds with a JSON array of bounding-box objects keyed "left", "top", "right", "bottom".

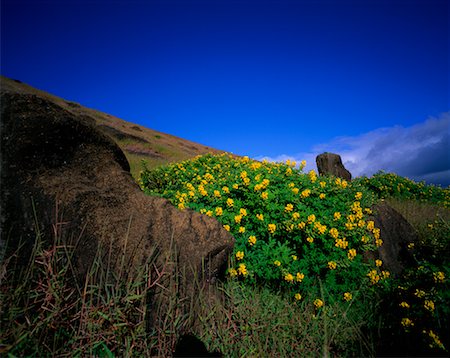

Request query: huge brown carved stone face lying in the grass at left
[{"left": 1, "top": 92, "right": 234, "bottom": 322}]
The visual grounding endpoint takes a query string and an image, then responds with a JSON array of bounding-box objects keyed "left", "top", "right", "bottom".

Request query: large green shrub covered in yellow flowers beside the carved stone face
[{"left": 141, "top": 154, "right": 389, "bottom": 309}]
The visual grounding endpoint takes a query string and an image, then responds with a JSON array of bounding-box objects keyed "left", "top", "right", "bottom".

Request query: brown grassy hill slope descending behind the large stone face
[{"left": 0, "top": 76, "right": 222, "bottom": 177}]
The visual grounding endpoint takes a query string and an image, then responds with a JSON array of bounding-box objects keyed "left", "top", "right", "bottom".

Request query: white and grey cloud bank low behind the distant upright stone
[{"left": 256, "top": 112, "right": 450, "bottom": 186}]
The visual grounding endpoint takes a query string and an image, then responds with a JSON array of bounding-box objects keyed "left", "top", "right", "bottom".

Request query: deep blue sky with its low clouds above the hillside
[{"left": 1, "top": 0, "right": 450, "bottom": 185}]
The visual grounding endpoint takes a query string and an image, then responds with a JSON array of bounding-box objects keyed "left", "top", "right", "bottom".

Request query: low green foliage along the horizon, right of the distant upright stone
[{"left": 356, "top": 171, "right": 450, "bottom": 207}]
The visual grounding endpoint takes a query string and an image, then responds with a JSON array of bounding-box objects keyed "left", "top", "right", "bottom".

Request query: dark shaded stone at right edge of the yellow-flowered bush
[{"left": 366, "top": 202, "right": 418, "bottom": 275}]
